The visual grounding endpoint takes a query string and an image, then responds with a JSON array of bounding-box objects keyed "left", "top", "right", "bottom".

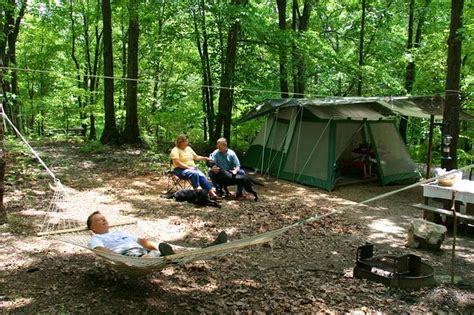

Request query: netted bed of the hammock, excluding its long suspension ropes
[{"left": 37, "top": 181, "right": 289, "bottom": 274}]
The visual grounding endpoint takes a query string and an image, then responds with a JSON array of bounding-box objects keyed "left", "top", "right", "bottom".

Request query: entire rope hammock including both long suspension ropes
[{"left": 0, "top": 104, "right": 474, "bottom": 274}]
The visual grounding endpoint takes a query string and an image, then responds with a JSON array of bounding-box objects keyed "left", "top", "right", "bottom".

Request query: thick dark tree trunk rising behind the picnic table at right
[{"left": 441, "top": 0, "right": 464, "bottom": 170}]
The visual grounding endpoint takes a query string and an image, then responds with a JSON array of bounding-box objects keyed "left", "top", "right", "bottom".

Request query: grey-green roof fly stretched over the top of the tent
[{"left": 240, "top": 96, "right": 474, "bottom": 122}]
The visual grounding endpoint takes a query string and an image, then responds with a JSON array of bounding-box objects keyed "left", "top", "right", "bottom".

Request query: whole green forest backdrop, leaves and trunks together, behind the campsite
[{"left": 0, "top": 0, "right": 474, "bottom": 164}]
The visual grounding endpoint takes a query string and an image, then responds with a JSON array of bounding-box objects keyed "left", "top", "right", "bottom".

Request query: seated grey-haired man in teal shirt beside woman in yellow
[{"left": 209, "top": 138, "right": 245, "bottom": 197}]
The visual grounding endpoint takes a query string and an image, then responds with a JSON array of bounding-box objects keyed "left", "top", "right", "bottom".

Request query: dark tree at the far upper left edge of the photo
[{"left": 0, "top": 0, "right": 27, "bottom": 130}]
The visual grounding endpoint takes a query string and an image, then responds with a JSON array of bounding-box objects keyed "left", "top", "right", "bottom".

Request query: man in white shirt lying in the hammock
[{"left": 87, "top": 211, "right": 227, "bottom": 257}]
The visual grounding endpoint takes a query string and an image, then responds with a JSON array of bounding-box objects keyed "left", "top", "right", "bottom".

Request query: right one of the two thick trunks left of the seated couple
[{"left": 123, "top": 0, "right": 141, "bottom": 144}]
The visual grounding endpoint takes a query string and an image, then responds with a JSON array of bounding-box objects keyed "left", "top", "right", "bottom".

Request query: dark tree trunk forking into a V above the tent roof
[{"left": 292, "top": 0, "right": 313, "bottom": 98}]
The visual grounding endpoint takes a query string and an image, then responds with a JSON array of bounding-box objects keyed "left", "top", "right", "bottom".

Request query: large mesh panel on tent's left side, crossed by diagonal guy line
[{"left": 284, "top": 121, "right": 329, "bottom": 180}]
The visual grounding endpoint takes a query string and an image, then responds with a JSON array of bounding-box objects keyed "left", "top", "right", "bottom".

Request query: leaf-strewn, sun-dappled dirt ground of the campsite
[{"left": 0, "top": 143, "right": 474, "bottom": 314}]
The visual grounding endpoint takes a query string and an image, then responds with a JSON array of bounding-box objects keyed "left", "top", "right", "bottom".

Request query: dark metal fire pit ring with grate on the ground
[{"left": 354, "top": 244, "right": 436, "bottom": 290}]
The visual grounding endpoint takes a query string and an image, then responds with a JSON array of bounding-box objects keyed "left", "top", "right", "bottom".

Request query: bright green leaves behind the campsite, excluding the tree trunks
[{"left": 5, "top": 0, "right": 474, "bottom": 168}]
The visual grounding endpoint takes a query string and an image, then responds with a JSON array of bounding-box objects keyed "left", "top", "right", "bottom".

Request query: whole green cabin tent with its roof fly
[{"left": 241, "top": 97, "right": 460, "bottom": 191}]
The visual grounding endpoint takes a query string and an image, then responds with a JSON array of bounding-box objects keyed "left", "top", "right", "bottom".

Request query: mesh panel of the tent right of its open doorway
[{"left": 370, "top": 122, "right": 416, "bottom": 176}]
